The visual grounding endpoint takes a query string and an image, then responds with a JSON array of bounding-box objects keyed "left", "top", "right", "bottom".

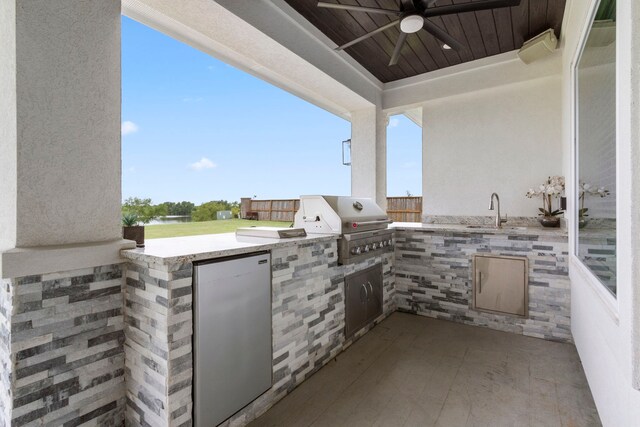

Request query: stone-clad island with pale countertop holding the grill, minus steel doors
[{"left": 117, "top": 233, "right": 395, "bottom": 426}]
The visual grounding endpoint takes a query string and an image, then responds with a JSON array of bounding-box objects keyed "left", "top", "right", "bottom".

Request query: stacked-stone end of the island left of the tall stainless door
[{"left": 124, "top": 261, "right": 193, "bottom": 427}]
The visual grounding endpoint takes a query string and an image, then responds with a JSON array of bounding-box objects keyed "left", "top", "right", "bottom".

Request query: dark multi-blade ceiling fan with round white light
[{"left": 318, "top": 0, "right": 521, "bottom": 65}]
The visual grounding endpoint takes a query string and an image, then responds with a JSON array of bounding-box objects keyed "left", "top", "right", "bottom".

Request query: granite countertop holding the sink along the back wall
[{"left": 390, "top": 222, "right": 568, "bottom": 237}]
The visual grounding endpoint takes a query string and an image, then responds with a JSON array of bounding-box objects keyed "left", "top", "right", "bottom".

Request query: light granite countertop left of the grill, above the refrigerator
[{"left": 121, "top": 233, "right": 338, "bottom": 264}]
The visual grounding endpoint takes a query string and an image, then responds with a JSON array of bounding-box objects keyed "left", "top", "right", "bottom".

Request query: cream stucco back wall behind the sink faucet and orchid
[{"left": 422, "top": 76, "right": 562, "bottom": 216}]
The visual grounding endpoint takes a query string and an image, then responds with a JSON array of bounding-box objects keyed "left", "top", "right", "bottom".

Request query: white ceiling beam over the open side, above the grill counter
[{"left": 122, "top": 0, "right": 381, "bottom": 119}]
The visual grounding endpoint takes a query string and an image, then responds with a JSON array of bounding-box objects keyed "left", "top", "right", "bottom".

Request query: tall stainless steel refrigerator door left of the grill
[{"left": 194, "top": 253, "right": 272, "bottom": 427}]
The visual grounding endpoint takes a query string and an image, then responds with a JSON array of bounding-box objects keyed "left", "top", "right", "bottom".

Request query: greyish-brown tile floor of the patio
[{"left": 250, "top": 313, "right": 600, "bottom": 427}]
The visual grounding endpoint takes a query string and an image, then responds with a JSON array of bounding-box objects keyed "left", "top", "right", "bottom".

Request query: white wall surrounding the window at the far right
[{"left": 562, "top": 0, "right": 640, "bottom": 426}]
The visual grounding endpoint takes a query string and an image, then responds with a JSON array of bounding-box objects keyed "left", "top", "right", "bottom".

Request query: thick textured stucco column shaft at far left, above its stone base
[{"left": 0, "top": 0, "right": 127, "bottom": 277}]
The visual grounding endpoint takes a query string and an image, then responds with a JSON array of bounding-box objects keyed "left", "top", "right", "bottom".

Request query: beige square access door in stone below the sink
[{"left": 473, "top": 256, "right": 528, "bottom": 316}]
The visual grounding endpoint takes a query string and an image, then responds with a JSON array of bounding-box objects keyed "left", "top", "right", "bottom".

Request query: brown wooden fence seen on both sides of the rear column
[{"left": 240, "top": 196, "right": 422, "bottom": 222}]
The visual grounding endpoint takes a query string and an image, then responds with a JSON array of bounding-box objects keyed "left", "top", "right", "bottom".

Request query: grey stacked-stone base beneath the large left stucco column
[{"left": 0, "top": 265, "right": 125, "bottom": 426}]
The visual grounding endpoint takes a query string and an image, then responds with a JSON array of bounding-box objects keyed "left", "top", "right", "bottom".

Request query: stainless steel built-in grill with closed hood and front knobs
[{"left": 294, "top": 196, "right": 393, "bottom": 264}]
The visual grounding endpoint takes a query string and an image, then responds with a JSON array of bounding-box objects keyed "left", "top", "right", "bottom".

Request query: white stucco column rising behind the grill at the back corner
[{"left": 351, "top": 107, "right": 388, "bottom": 209}]
